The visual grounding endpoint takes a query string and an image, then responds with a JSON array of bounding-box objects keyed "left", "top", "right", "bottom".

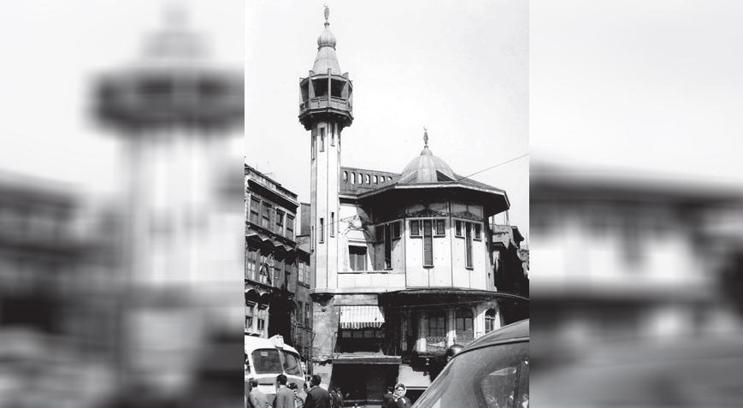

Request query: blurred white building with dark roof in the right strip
[{"left": 530, "top": 165, "right": 741, "bottom": 356}]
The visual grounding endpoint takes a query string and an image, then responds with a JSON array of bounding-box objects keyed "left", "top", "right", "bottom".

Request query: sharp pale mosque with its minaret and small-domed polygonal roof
[{"left": 299, "top": 9, "right": 524, "bottom": 403}]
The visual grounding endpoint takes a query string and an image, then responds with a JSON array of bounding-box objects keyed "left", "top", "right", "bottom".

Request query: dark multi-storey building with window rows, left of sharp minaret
[{"left": 245, "top": 164, "right": 312, "bottom": 359}]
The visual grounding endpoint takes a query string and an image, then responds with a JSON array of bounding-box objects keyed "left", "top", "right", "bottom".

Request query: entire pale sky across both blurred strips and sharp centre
[{"left": 0, "top": 0, "right": 743, "bottom": 239}]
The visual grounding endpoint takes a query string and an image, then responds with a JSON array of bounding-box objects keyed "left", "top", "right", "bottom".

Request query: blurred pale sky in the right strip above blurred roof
[{"left": 529, "top": 0, "right": 743, "bottom": 186}]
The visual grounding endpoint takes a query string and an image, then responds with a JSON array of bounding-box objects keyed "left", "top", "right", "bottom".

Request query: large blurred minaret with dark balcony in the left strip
[{"left": 95, "top": 6, "right": 244, "bottom": 404}]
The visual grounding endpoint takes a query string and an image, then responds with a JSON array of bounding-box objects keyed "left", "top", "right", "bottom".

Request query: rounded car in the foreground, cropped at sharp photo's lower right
[{"left": 413, "top": 343, "right": 529, "bottom": 408}]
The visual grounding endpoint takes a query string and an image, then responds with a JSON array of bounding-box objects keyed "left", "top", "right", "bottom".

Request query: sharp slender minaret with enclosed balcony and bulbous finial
[{"left": 299, "top": 7, "right": 353, "bottom": 291}]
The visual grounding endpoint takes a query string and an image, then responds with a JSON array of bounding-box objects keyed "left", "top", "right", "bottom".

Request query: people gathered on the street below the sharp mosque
[{"left": 246, "top": 374, "right": 411, "bottom": 408}]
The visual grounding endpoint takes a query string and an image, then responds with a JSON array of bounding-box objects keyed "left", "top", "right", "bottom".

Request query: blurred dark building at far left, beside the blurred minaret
[{"left": 0, "top": 173, "right": 120, "bottom": 407}]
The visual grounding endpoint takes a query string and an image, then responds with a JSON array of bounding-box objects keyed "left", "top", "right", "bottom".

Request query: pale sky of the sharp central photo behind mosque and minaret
[{"left": 245, "top": 0, "right": 529, "bottom": 233}]
